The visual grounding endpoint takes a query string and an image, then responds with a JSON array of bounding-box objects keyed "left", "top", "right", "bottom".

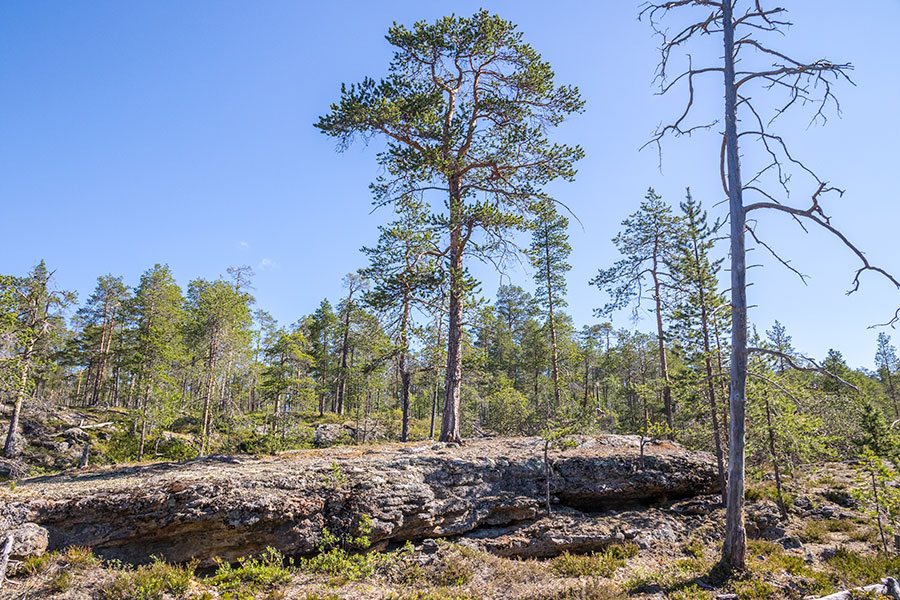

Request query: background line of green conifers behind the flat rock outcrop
[{"left": 0, "top": 190, "right": 900, "bottom": 492}]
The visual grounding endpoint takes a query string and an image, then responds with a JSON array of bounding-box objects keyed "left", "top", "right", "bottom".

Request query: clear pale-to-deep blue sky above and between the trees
[{"left": 0, "top": 0, "right": 900, "bottom": 367}]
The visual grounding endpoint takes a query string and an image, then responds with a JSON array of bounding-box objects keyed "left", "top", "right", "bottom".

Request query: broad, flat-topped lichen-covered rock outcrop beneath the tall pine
[{"left": 0, "top": 436, "right": 717, "bottom": 564}]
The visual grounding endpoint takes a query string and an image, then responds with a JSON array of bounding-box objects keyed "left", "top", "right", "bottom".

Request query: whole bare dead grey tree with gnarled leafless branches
[{"left": 640, "top": 0, "right": 900, "bottom": 569}]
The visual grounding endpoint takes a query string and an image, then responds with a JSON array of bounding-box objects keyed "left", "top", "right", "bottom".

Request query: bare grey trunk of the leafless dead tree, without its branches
[{"left": 722, "top": 2, "right": 747, "bottom": 571}]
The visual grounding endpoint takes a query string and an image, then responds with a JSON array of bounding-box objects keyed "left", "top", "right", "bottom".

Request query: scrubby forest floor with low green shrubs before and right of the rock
[{"left": 0, "top": 454, "right": 900, "bottom": 600}]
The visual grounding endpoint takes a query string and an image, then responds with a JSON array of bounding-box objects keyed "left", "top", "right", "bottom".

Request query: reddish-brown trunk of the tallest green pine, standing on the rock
[{"left": 438, "top": 175, "right": 465, "bottom": 443}]
